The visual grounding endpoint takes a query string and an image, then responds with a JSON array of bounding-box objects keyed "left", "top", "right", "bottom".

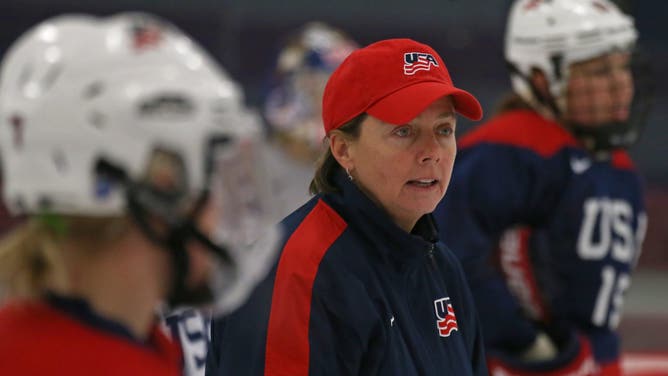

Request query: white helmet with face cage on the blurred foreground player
[{"left": 0, "top": 14, "right": 277, "bottom": 313}]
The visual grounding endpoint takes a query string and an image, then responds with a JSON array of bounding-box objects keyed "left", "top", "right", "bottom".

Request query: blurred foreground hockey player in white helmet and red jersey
[{"left": 0, "top": 14, "right": 275, "bottom": 375}]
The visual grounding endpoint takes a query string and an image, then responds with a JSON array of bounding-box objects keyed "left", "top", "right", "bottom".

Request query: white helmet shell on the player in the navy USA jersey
[{"left": 505, "top": 0, "right": 637, "bottom": 102}]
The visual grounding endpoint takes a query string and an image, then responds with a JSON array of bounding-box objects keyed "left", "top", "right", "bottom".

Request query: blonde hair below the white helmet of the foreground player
[{"left": 0, "top": 216, "right": 130, "bottom": 299}]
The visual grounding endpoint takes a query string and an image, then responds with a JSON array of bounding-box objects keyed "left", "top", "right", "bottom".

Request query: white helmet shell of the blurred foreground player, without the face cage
[{"left": 0, "top": 14, "right": 248, "bottom": 216}]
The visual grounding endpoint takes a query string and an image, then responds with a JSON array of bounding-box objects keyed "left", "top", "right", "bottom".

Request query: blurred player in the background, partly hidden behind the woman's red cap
[{"left": 264, "top": 22, "right": 357, "bottom": 220}]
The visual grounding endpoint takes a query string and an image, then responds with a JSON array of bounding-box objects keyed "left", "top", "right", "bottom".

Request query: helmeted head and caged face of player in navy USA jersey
[{"left": 505, "top": 0, "right": 653, "bottom": 152}]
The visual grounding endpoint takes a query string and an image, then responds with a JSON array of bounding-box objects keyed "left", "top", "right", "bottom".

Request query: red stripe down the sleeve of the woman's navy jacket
[{"left": 264, "top": 200, "right": 347, "bottom": 376}]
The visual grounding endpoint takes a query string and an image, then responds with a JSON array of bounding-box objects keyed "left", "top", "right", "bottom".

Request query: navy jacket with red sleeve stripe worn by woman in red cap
[{"left": 206, "top": 174, "right": 487, "bottom": 376}]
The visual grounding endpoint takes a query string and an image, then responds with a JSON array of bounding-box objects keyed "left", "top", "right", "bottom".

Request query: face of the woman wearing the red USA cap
[{"left": 344, "top": 97, "right": 457, "bottom": 231}]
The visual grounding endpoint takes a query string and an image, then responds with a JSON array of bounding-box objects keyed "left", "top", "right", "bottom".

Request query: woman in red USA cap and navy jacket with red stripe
[{"left": 206, "top": 39, "right": 487, "bottom": 375}]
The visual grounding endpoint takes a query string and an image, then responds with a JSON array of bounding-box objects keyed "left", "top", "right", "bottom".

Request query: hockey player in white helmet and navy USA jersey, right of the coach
[{"left": 435, "top": 0, "right": 648, "bottom": 375}]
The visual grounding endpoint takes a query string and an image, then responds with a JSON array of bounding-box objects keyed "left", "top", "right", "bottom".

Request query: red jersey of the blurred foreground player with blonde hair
[{"left": 0, "top": 296, "right": 181, "bottom": 376}]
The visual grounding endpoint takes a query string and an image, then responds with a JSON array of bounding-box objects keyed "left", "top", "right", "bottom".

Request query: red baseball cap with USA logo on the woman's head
[{"left": 322, "top": 39, "right": 482, "bottom": 133}]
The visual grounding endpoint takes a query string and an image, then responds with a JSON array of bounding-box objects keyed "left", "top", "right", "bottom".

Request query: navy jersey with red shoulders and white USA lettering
[{"left": 434, "top": 110, "right": 647, "bottom": 364}]
